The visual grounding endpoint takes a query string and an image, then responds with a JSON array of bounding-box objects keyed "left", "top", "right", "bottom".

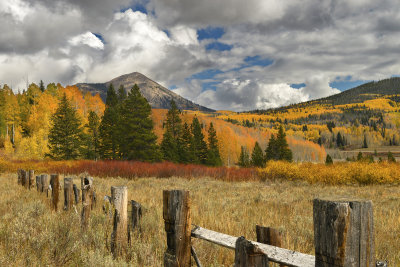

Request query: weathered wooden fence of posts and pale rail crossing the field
[{"left": 18, "top": 170, "right": 387, "bottom": 267}]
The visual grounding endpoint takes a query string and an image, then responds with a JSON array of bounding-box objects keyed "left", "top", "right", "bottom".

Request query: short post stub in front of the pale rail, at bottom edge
[{"left": 234, "top": 236, "right": 268, "bottom": 267}]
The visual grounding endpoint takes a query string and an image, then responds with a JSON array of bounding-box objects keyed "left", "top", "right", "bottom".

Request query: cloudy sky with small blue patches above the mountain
[{"left": 0, "top": 0, "right": 400, "bottom": 111}]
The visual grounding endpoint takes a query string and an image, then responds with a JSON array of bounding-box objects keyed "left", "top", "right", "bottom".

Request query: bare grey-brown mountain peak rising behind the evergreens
[{"left": 76, "top": 72, "right": 214, "bottom": 112}]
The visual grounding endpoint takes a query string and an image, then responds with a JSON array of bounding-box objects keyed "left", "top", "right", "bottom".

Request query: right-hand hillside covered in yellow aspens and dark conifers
[{"left": 218, "top": 77, "right": 400, "bottom": 160}]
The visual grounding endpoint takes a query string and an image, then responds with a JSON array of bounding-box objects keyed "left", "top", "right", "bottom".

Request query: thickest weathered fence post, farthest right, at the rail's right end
[{"left": 313, "top": 199, "right": 375, "bottom": 267}]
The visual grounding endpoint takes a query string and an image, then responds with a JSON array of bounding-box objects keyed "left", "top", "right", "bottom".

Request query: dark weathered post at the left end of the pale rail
[{"left": 163, "top": 190, "right": 192, "bottom": 267}]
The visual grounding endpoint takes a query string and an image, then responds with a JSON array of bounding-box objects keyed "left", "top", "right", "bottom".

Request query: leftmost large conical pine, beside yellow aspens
[{"left": 49, "top": 94, "right": 83, "bottom": 160}]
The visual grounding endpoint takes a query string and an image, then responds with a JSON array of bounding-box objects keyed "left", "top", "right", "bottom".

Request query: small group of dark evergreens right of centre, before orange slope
[{"left": 237, "top": 125, "right": 293, "bottom": 167}]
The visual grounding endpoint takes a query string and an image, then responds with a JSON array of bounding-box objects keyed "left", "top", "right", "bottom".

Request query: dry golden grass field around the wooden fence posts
[{"left": 0, "top": 173, "right": 400, "bottom": 266}]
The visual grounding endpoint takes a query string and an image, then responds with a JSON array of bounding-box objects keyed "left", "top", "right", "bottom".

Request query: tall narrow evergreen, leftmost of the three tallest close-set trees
[{"left": 99, "top": 84, "right": 120, "bottom": 159}]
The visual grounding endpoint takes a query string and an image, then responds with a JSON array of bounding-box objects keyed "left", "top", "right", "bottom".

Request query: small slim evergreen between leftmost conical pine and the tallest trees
[{"left": 84, "top": 110, "right": 100, "bottom": 160}]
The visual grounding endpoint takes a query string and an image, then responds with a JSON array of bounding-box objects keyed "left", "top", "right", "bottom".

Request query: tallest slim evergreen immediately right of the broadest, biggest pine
[{"left": 161, "top": 100, "right": 182, "bottom": 162}]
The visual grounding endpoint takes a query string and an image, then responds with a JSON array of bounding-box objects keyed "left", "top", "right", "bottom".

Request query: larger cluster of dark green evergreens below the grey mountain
[{"left": 48, "top": 84, "right": 222, "bottom": 166}]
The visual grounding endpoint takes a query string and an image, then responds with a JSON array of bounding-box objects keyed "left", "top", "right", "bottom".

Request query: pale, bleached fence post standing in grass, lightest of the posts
[{"left": 111, "top": 186, "right": 128, "bottom": 258}]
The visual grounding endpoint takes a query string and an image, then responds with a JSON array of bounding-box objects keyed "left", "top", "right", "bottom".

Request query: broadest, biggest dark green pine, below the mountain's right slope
[{"left": 121, "top": 84, "right": 161, "bottom": 162}]
